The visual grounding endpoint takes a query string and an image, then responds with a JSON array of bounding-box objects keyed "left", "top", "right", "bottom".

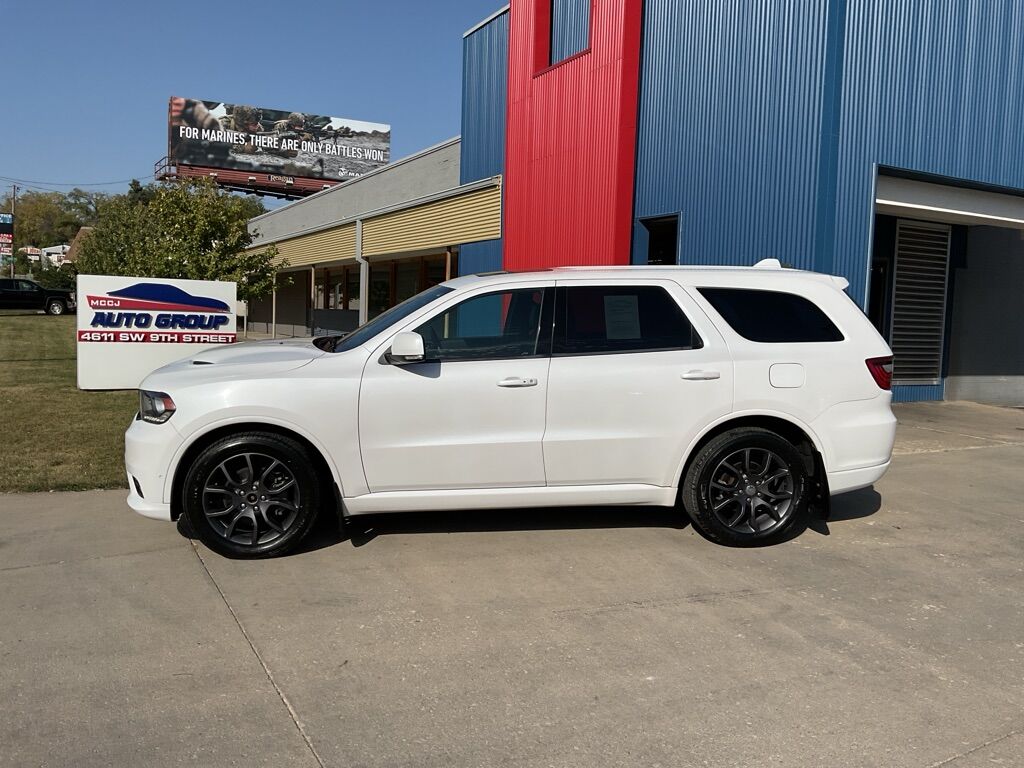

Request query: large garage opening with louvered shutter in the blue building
[{"left": 867, "top": 176, "right": 1024, "bottom": 406}]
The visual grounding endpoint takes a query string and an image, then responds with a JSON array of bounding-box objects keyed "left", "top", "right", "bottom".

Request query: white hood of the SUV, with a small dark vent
[{"left": 140, "top": 339, "right": 325, "bottom": 391}]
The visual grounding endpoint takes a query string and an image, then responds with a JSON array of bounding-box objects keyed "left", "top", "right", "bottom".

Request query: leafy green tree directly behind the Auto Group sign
[{"left": 78, "top": 179, "right": 282, "bottom": 301}]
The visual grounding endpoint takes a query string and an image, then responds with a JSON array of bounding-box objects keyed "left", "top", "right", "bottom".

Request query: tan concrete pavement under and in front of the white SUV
[{"left": 0, "top": 403, "right": 1024, "bottom": 768}]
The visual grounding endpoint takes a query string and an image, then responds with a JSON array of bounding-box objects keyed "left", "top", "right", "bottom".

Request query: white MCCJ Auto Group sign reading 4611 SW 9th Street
[{"left": 76, "top": 274, "right": 237, "bottom": 389}]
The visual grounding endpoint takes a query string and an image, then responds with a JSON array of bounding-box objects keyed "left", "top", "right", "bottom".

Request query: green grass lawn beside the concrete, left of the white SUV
[{"left": 0, "top": 314, "right": 138, "bottom": 493}]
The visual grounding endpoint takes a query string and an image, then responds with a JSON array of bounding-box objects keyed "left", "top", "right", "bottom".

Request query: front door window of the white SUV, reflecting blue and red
[{"left": 416, "top": 288, "right": 551, "bottom": 361}]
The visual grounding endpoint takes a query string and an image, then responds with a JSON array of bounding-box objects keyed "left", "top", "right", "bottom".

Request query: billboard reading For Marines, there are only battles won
[{"left": 167, "top": 96, "right": 391, "bottom": 181}]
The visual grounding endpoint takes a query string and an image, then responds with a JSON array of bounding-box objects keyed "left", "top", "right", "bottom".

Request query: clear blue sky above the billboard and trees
[{"left": 0, "top": 0, "right": 504, "bottom": 198}]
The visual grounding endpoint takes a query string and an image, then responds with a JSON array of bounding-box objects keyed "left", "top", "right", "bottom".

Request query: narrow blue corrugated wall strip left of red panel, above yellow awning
[{"left": 459, "top": 11, "right": 509, "bottom": 184}]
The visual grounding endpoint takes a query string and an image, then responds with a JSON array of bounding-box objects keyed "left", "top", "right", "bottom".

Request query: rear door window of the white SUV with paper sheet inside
[{"left": 553, "top": 286, "right": 702, "bottom": 354}]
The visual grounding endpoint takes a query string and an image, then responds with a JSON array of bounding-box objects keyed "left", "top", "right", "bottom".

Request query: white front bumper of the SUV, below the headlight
[{"left": 125, "top": 419, "right": 182, "bottom": 520}]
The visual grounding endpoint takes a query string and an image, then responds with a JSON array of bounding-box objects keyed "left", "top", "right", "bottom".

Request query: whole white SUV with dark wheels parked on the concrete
[{"left": 125, "top": 261, "right": 896, "bottom": 556}]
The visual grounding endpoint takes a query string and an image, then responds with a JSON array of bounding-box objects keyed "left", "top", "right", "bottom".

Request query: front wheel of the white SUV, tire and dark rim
[{"left": 181, "top": 432, "right": 321, "bottom": 558}]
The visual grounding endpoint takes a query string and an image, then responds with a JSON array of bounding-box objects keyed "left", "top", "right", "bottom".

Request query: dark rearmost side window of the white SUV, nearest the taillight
[{"left": 697, "top": 288, "right": 843, "bottom": 344}]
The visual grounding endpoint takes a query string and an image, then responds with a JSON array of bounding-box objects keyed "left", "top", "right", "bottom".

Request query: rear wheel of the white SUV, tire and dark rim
[{"left": 680, "top": 427, "right": 811, "bottom": 547}]
